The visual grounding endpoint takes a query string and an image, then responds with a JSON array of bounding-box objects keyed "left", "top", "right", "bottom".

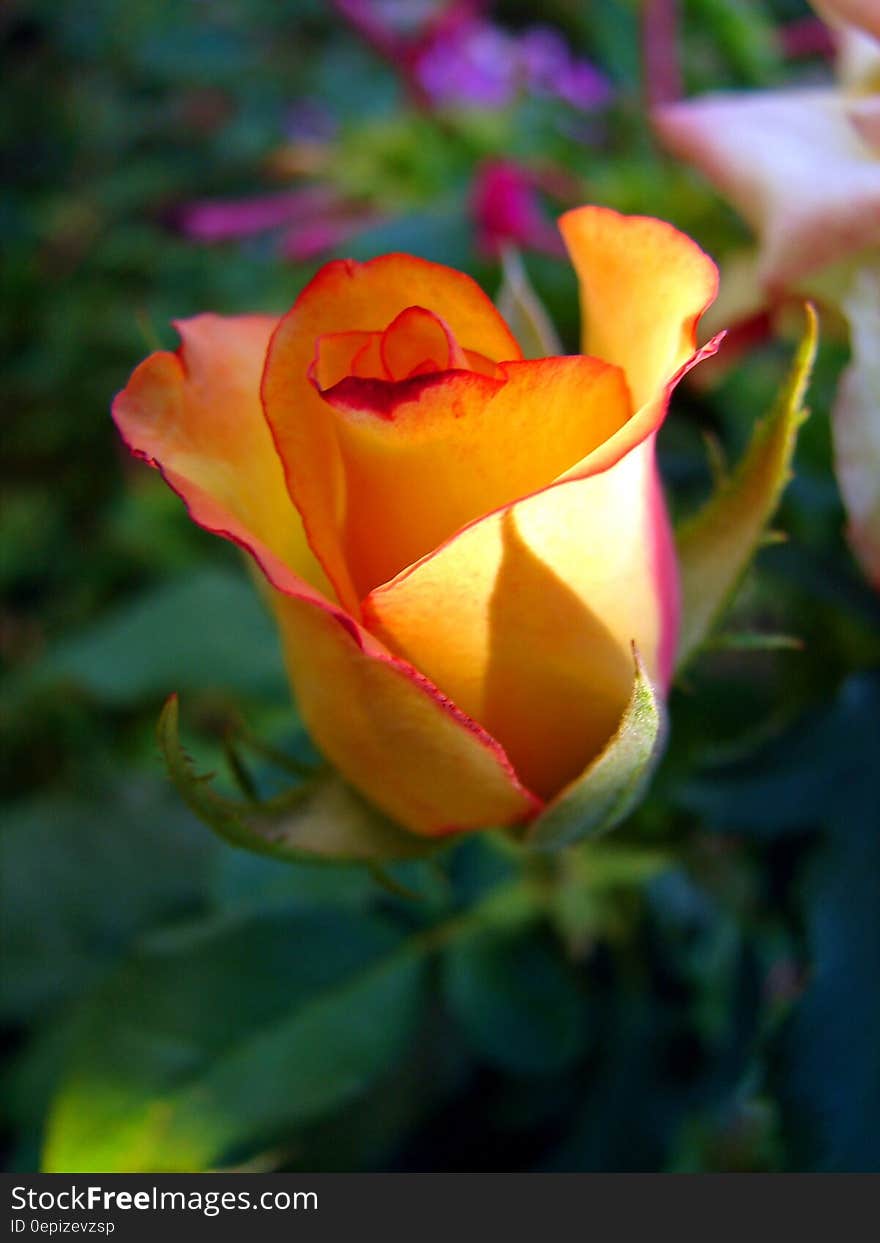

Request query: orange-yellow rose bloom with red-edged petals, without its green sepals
[{"left": 114, "top": 208, "right": 717, "bottom": 835}]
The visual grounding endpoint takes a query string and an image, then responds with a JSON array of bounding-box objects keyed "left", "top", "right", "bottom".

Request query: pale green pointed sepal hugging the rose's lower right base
[{"left": 526, "top": 648, "right": 665, "bottom": 849}]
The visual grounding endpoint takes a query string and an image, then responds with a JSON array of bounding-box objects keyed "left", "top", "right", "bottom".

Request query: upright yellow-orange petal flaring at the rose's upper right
[{"left": 559, "top": 206, "right": 718, "bottom": 410}]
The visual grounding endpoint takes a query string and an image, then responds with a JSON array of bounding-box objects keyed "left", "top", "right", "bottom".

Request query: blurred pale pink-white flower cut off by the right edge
[{"left": 654, "top": 0, "right": 880, "bottom": 587}]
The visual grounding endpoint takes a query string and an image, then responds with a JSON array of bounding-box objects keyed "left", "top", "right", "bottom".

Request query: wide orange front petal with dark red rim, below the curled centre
[{"left": 313, "top": 357, "right": 630, "bottom": 595}]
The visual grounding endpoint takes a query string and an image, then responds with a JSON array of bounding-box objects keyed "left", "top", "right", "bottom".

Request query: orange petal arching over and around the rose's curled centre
[{"left": 262, "top": 255, "right": 521, "bottom": 612}]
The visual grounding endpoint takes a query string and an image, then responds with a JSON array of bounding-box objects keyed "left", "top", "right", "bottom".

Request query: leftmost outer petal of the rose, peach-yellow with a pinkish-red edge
[{"left": 113, "top": 314, "right": 327, "bottom": 589}]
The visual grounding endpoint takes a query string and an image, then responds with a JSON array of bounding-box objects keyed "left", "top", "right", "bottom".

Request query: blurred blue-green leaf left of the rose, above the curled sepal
[{"left": 41, "top": 569, "right": 287, "bottom": 704}]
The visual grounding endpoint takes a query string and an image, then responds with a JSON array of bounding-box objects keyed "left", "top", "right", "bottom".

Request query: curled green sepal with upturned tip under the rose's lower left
[{"left": 158, "top": 695, "right": 436, "bottom": 861}]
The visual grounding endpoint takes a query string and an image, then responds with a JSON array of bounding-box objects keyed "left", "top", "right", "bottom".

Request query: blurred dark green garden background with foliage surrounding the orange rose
[{"left": 0, "top": 0, "right": 880, "bottom": 1171}]
